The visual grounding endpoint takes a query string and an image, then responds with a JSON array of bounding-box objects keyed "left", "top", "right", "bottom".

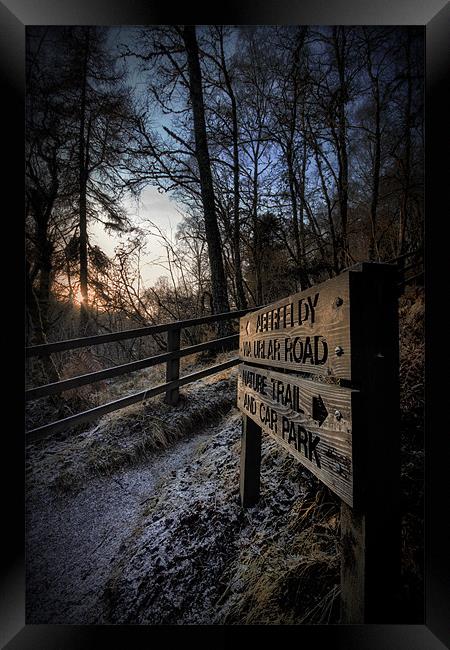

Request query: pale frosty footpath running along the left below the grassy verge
[{"left": 26, "top": 412, "right": 229, "bottom": 623}]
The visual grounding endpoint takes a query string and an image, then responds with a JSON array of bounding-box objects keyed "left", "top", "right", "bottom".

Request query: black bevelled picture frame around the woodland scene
[{"left": 0, "top": 0, "right": 450, "bottom": 650}]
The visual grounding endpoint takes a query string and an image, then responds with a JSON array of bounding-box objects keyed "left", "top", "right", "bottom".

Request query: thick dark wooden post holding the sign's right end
[{"left": 341, "top": 263, "right": 400, "bottom": 624}]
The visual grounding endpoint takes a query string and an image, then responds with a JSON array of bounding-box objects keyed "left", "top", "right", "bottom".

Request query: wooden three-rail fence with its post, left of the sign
[{"left": 25, "top": 307, "right": 259, "bottom": 442}]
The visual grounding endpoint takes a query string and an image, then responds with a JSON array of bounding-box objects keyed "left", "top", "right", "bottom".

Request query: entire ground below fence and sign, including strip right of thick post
[{"left": 26, "top": 286, "right": 423, "bottom": 624}]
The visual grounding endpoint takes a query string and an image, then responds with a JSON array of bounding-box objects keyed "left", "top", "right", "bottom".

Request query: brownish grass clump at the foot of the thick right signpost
[{"left": 223, "top": 485, "right": 340, "bottom": 625}]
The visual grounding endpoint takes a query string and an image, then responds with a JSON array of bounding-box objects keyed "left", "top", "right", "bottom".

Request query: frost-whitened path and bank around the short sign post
[{"left": 26, "top": 374, "right": 312, "bottom": 624}]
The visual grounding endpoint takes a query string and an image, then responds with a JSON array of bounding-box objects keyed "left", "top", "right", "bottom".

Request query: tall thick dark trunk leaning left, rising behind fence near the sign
[{"left": 182, "top": 25, "right": 230, "bottom": 336}]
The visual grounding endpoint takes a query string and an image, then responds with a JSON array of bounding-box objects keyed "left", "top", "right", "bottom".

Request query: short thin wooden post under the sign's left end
[{"left": 240, "top": 415, "right": 262, "bottom": 508}]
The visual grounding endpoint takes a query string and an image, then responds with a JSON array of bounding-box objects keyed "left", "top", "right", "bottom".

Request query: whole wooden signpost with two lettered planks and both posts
[{"left": 238, "top": 263, "right": 400, "bottom": 623}]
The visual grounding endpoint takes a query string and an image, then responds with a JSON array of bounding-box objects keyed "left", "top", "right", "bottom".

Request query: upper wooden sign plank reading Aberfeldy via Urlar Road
[{"left": 239, "top": 272, "right": 351, "bottom": 380}]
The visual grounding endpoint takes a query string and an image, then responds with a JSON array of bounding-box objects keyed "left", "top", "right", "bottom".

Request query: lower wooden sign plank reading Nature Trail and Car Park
[{"left": 238, "top": 364, "right": 357, "bottom": 506}]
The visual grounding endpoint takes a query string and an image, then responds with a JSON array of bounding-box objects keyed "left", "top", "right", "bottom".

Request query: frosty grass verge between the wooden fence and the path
[{"left": 28, "top": 371, "right": 236, "bottom": 492}]
